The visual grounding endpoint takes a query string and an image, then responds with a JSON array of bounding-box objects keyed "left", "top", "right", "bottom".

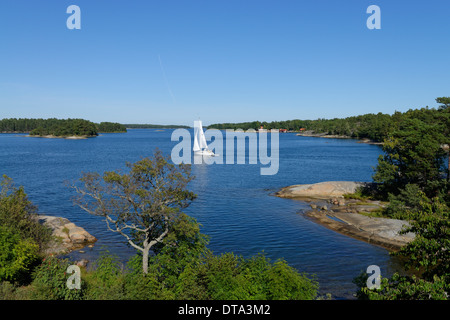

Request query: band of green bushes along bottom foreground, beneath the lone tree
[{"left": 0, "top": 252, "right": 318, "bottom": 300}]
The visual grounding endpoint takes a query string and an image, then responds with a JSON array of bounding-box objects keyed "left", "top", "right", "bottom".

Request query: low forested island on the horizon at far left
[{"left": 0, "top": 118, "right": 127, "bottom": 137}]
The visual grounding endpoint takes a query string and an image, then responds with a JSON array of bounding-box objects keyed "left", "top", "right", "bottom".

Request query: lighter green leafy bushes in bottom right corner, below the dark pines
[{"left": 355, "top": 196, "right": 450, "bottom": 300}]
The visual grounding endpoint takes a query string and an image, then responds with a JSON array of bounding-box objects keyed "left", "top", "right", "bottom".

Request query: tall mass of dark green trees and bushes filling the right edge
[{"left": 356, "top": 97, "right": 450, "bottom": 300}]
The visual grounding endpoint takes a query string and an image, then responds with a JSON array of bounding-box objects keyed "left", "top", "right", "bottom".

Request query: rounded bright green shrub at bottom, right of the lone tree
[{"left": 178, "top": 253, "right": 318, "bottom": 300}]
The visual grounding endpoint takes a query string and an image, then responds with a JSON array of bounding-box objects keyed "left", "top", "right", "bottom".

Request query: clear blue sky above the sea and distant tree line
[{"left": 0, "top": 0, "right": 450, "bottom": 125}]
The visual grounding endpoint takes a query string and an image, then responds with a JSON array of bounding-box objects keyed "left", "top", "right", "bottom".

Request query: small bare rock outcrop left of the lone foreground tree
[{"left": 38, "top": 215, "right": 97, "bottom": 255}]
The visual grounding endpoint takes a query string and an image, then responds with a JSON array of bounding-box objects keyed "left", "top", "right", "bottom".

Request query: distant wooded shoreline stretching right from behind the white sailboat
[{"left": 208, "top": 97, "right": 450, "bottom": 142}]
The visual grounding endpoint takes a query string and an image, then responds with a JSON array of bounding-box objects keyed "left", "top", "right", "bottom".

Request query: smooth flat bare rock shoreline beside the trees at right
[{"left": 275, "top": 181, "right": 414, "bottom": 251}]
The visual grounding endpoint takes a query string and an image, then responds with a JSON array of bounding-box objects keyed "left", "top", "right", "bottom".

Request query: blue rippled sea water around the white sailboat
[{"left": 0, "top": 129, "right": 399, "bottom": 299}]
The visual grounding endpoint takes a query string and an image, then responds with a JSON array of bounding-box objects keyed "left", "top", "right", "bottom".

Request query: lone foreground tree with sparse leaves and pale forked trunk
[{"left": 73, "top": 151, "right": 196, "bottom": 273}]
